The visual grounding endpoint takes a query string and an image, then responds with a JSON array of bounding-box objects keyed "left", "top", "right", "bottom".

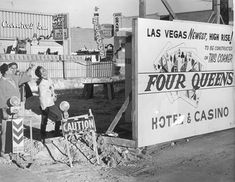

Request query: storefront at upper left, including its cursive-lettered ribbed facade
[{"left": 0, "top": 10, "right": 70, "bottom": 54}]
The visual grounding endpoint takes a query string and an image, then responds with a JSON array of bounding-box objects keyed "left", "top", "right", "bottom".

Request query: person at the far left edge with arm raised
[{"left": 0, "top": 63, "right": 31, "bottom": 155}]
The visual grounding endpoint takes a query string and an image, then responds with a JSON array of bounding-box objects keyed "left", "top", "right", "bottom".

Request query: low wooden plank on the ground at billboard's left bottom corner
[{"left": 102, "top": 136, "right": 136, "bottom": 148}]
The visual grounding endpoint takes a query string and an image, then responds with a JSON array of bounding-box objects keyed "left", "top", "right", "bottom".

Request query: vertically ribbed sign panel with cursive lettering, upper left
[{"left": 0, "top": 10, "right": 52, "bottom": 40}]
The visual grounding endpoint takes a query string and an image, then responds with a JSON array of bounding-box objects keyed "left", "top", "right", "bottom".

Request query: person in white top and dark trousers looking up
[{"left": 35, "top": 66, "right": 62, "bottom": 140}]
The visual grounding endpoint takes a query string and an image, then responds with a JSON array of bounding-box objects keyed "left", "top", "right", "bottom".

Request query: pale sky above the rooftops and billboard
[{"left": 0, "top": 0, "right": 232, "bottom": 28}]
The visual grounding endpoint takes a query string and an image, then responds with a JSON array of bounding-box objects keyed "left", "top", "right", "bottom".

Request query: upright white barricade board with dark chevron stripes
[{"left": 12, "top": 118, "right": 24, "bottom": 153}]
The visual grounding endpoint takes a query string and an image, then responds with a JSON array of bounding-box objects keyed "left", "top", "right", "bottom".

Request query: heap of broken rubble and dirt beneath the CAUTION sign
[{"left": 5, "top": 133, "right": 151, "bottom": 168}]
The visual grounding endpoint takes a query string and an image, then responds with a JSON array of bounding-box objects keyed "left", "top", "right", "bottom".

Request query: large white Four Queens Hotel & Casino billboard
[{"left": 133, "top": 19, "right": 235, "bottom": 147}]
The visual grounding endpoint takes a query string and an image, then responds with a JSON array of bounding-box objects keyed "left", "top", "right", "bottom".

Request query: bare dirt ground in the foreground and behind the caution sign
[{"left": 0, "top": 85, "right": 235, "bottom": 182}]
